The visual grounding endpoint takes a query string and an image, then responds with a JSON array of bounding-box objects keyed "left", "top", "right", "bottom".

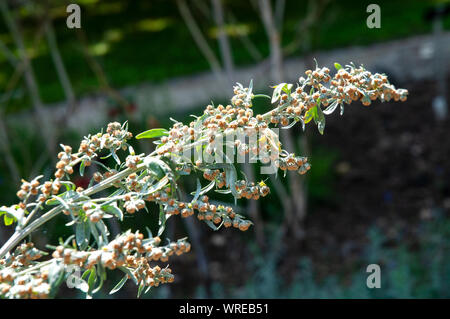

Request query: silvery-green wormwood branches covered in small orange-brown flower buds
[{"left": 0, "top": 63, "right": 408, "bottom": 298}]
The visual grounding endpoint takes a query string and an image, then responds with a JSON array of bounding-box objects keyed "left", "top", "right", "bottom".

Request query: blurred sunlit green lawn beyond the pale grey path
[{"left": 0, "top": 0, "right": 450, "bottom": 111}]
